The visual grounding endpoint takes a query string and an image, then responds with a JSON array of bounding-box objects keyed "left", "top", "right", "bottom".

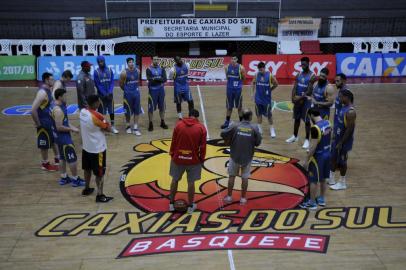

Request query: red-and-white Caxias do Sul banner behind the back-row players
[{"left": 141, "top": 56, "right": 231, "bottom": 81}]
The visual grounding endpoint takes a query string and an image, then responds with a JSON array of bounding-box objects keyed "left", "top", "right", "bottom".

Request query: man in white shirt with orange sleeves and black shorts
[{"left": 80, "top": 95, "right": 113, "bottom": 203}]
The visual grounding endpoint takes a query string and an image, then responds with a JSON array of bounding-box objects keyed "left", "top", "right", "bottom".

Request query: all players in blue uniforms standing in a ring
[{"left": 32, "top": 53, "right": 356, "bottom": 209}]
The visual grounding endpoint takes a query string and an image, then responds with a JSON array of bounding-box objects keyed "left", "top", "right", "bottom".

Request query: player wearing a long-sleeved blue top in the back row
[{"left": 93, "top": 55, "right": 118, "bottom": 134}]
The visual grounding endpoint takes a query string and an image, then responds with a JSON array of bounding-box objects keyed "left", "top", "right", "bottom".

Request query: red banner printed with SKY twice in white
[{"left": 242, "top": 54, "right": 336, "bottom": 79}]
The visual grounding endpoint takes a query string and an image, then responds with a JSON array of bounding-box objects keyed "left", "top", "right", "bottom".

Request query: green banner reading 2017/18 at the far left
[{"left": 0, "top": 55, "right": 35, "bottom": 81}]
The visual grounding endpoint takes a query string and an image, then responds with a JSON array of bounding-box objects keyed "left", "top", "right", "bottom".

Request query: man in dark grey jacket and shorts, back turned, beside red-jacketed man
[{"left": 221, "top": 109, "right": 262, "bottom": 205}]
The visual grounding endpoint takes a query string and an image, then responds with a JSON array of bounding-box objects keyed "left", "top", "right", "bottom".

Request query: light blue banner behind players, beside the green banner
[{"left": 37, "top": 55, "right": 136, "bottom": 80}]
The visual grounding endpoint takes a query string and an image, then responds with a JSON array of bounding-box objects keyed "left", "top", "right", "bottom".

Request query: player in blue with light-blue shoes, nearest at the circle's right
[{"left": 300, "top": 108, "right": 332, "bottom": 210}]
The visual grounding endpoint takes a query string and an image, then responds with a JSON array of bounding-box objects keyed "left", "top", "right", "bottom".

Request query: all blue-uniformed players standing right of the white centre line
[{"left": 221, "top": 57, "right": 356, "bottom": 210}]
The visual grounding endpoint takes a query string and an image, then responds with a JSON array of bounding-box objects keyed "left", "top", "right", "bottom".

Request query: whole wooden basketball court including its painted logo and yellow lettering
[{"left": 0, "top": 83, "right": 406, "bottom": 270}]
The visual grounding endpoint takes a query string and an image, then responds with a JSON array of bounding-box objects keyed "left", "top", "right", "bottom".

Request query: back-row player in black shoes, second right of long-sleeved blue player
[{"left": 146, "top": 56, "right": 168, "bottom": 131}]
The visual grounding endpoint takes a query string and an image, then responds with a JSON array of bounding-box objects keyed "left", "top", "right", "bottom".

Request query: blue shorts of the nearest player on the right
[{"left": 309, "top": 152, "right": 330, "bottom": 183}]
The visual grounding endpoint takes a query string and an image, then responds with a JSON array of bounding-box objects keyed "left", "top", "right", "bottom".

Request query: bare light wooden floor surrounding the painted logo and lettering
[{"left": 0, "top": 84, "right": 406, "bottom": 270}]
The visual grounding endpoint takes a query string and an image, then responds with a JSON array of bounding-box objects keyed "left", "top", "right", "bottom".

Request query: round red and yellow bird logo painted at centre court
[{"left": 120, "top": 139, "right": 309, "bottom": 225}]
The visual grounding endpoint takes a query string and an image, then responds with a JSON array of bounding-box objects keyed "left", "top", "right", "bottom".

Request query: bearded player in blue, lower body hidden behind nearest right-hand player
[{"left": 311, "top": 68, "right": 334, "bottom": 120}]
